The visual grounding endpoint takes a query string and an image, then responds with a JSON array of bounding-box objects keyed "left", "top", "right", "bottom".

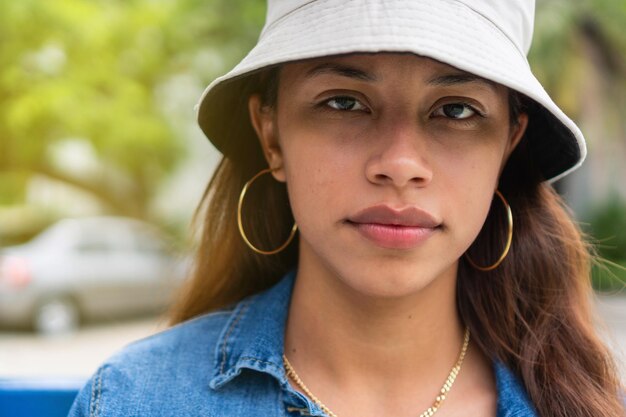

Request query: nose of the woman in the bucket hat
[{"left": 365, "top": 124, "right": 433, "bottom": 189}]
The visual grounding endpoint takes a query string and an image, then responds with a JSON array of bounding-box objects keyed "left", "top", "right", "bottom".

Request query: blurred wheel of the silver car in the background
[{"left": 33, "top": 297, "right": 80, "bottom": 335}]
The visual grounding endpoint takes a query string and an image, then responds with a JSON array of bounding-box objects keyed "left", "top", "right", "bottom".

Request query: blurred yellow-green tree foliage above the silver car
[{"left": 0, "top": 0, "right": 264, "bottom": 223}]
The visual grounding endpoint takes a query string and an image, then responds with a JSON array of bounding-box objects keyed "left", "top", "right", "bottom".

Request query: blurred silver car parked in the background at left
[{"left": 0, "top": 217, "right": 189, "bottom": 333}]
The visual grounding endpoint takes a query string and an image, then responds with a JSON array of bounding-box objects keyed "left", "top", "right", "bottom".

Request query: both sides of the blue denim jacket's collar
[{"left": 209, "top": 271, "right": 537, "bottom": 417}]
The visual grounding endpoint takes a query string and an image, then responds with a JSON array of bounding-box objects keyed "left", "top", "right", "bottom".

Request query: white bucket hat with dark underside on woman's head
[{"left": 197, "top": 0, "right": 586, "bottom": 181}]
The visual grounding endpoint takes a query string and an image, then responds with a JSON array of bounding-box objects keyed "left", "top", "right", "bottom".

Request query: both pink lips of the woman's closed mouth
[{"left": 346, "top": 205, "right": 441, "bottom": 249}]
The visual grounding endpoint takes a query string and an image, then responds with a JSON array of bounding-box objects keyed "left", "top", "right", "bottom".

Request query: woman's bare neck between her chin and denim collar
[{"left": 285, "top": 252, "right": 472, "bottom": 415}]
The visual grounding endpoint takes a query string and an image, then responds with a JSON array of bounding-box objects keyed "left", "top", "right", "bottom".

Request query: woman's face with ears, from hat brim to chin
[{"left": 250, "top": 53, "right": 526, "bottom": 297}]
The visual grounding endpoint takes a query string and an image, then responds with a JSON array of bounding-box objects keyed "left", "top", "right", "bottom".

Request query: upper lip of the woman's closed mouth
[{"left": 348, "top": 204, "right": 441, "bottom": 228}]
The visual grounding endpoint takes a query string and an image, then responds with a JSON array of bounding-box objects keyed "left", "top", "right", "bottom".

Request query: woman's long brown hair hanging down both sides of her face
[{"left": 171, "top": 70, "right": 624, "bottom": 417}]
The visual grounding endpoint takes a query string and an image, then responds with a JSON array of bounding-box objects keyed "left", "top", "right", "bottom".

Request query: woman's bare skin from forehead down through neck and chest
[{"left": 249, "top": 53, "right": 527, "bottom": 417}]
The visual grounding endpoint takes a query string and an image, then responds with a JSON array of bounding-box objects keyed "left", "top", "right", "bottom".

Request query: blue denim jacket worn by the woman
[{"left": 69, "top": 272, "right": 537, "bottom": 417}]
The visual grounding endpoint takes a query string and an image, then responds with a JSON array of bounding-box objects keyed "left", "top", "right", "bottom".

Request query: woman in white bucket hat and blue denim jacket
[{"left": 71, "top": 0, "right": 624, "bottom": 417}]
